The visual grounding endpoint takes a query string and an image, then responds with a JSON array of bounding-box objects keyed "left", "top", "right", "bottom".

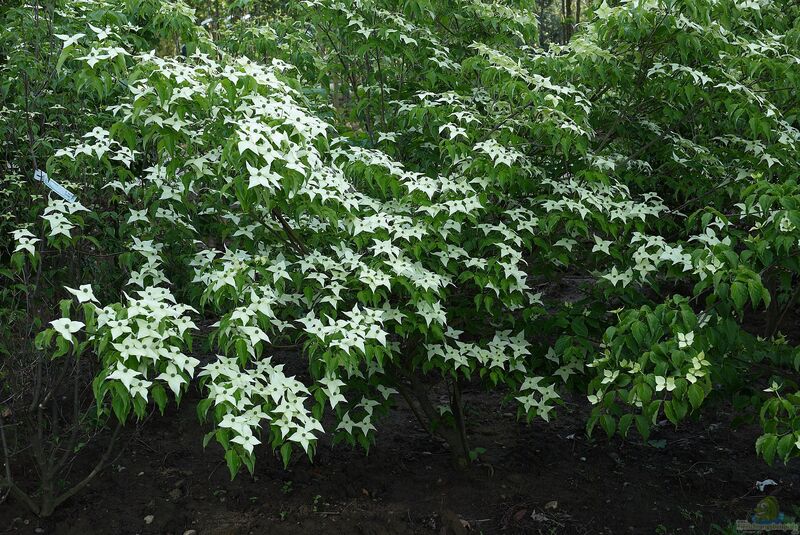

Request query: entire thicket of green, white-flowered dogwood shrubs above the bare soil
[{"left": 0, "top": 0, "right": 800, "bottom": 516}]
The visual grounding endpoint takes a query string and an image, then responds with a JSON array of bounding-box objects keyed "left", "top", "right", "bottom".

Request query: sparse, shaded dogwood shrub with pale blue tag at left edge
[{"left": 0, "top": 0, "right": 202, "bottom": 516}]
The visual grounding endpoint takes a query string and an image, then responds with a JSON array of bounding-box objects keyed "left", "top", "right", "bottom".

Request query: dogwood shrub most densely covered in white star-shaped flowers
[{"left": 45, "top": 24, "right": 556, "bottom": 469}]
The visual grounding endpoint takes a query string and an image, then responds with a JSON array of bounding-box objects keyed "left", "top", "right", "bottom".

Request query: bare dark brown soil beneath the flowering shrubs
[{"left": 0, "top": 382, "right": 800, "bottom": 535}]
